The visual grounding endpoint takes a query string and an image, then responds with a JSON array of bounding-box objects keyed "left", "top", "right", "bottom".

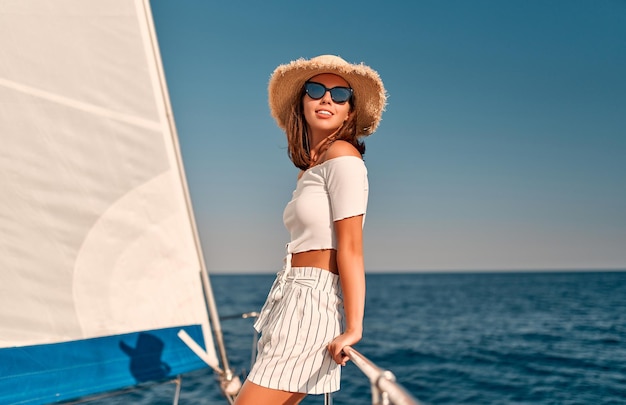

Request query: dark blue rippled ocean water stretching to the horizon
[{"left": 94, "top": 272, "right": 626, "bottom": 405}]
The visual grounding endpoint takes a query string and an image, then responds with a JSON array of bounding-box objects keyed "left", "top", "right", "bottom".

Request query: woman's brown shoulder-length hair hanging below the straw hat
[{"left": 285, "top": 87, "right": 365, "bottom": 170}]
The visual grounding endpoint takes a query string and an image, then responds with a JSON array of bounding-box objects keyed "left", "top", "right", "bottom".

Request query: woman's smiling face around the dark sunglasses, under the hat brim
[{"left": 302, "top": 73, "right": 350, "bottom": 135}]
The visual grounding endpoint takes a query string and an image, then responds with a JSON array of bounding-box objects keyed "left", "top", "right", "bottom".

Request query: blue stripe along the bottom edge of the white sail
[{"left": 0, "top": 325, "right": 207, "bottom": 405}]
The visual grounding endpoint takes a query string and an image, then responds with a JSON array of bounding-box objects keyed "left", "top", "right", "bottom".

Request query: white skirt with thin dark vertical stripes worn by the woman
[{"left": 248, "top": 267, "right": 344, "bottom": 394}]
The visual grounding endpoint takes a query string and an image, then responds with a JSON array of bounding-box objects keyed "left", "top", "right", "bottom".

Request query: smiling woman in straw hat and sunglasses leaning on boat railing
[{"left": 235, "top": 55, "right": 386, "bottom": 405}]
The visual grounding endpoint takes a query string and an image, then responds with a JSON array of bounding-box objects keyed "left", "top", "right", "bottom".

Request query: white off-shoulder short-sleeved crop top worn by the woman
[{"left": 283, "top": 156, "right": 369, "bottom": 253}]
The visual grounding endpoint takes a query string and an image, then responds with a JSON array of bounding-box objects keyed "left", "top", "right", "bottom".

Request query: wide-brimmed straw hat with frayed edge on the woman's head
[{"left": 268, "top": 55, "right": 387, "bottom": 135}]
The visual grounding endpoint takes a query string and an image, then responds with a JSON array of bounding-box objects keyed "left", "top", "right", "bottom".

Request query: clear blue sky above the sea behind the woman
[{"left": 151, "top": 0, "right": 626, "bottom": 273}]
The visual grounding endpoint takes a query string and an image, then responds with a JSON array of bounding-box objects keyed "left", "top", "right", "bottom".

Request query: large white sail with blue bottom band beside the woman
[{"left": 0, "top": 0, "right": 217, "bottom": 404}]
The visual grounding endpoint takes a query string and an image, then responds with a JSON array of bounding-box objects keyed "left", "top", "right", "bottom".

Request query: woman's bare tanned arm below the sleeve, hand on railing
[{"left": 328, "top": 215, "right": 365, "bottom": 365}]
